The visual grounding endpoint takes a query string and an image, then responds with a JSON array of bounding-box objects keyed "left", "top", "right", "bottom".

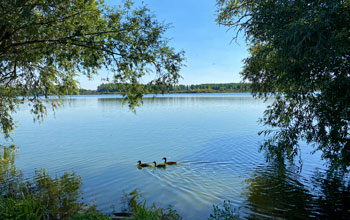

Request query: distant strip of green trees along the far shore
[{"left": 75, "top": 83, "right": 251, "bottom": 95}]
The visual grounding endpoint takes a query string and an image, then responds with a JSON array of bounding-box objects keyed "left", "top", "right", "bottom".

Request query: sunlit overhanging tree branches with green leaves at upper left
[{"left": 0, "top": 0, "right": 184, "bottom": 138}]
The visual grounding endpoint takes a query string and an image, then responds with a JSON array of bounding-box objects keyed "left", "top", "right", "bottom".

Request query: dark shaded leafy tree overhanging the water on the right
[{"left": 217, "top": 0, "right": 350, "bottom": 169}]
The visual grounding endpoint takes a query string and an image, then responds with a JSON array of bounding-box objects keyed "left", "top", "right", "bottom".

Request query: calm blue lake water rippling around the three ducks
[{"left": 1, "top": 94, "right": 350, "bottom": 220}]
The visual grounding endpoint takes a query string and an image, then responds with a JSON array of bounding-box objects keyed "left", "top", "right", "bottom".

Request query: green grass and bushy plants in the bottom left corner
[{"left": 0, "top": 170, "right": 85, "bottom": 219}]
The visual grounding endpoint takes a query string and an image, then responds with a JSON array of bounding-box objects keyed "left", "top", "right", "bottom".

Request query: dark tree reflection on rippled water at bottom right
[{"left": 241, "top": 161, "right": 350, "bottom": 219}]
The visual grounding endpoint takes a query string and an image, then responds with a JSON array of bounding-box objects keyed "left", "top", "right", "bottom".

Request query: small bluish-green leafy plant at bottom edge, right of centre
[{"left": 209, "top": 200, "right": 240, "bottom": 220}]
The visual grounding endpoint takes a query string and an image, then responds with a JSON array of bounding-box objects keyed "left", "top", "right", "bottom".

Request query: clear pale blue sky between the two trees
[{"left": 78, "top": 0, "right": 248, "bottom": 89}]
